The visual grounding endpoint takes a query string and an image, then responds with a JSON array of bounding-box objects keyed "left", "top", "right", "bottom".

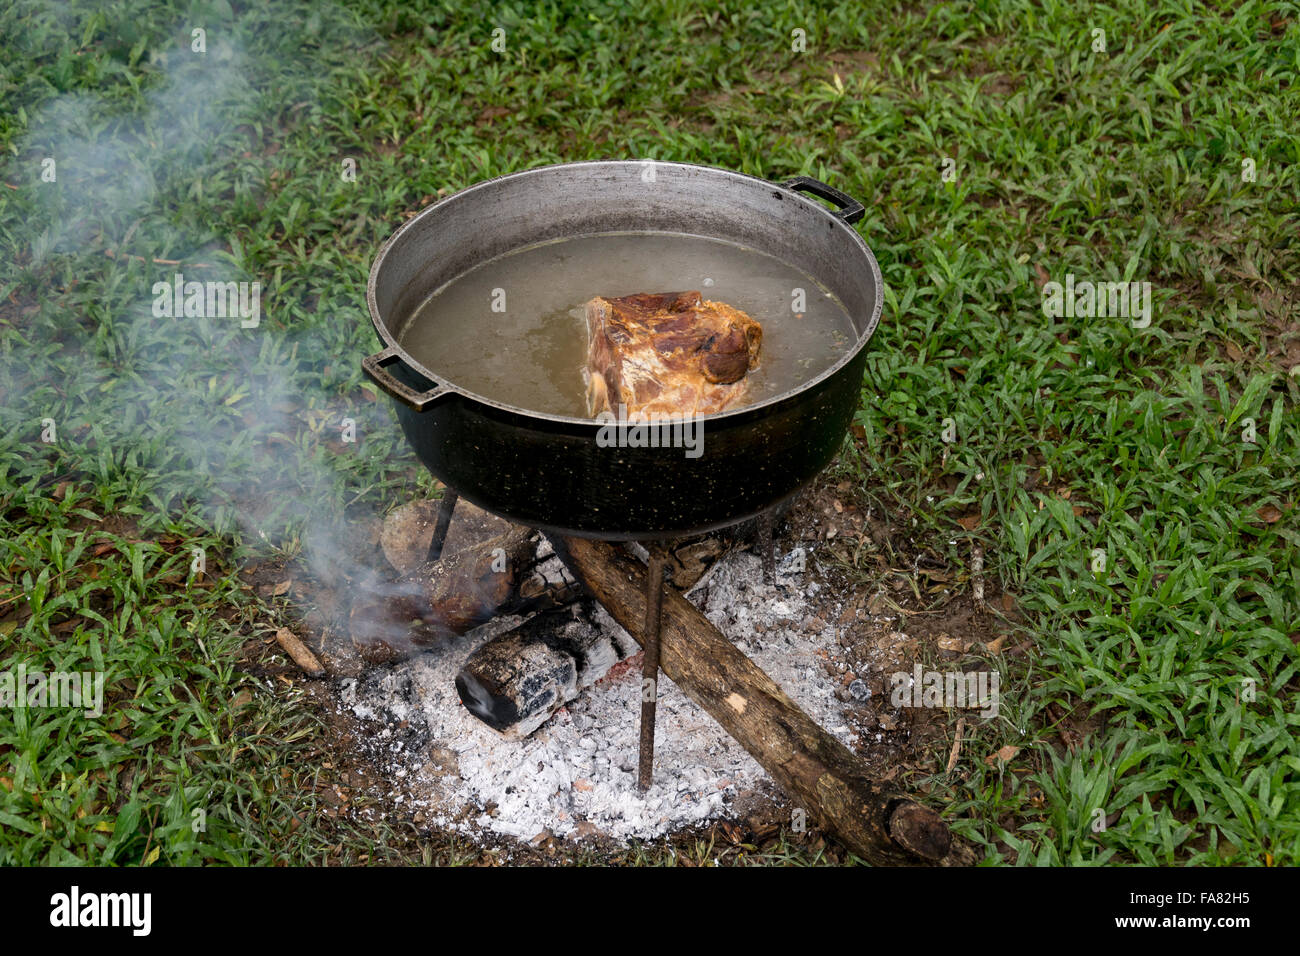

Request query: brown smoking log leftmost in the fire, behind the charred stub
[{"left": 350, "top": 527, "right": 534, "bottom": 663}]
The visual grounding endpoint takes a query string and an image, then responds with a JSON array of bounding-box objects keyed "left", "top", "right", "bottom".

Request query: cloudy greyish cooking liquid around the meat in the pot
[{"left": 398, "top": 233, "right": 857, "bottom": 418}]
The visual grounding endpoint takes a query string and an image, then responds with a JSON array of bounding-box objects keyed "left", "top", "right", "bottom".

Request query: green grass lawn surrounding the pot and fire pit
[{"left": 0, "top": 0, "right": 1300, "bottom": 865}]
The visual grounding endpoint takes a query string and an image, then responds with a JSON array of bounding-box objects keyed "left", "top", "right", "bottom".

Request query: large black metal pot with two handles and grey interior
[{"left": 361, "top": 161, "right": 881, "bottom": 540}]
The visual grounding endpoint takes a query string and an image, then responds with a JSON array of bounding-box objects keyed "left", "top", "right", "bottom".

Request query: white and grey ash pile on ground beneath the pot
[{"left": 339, "top": 551, "right": 875, "bottom": 840}]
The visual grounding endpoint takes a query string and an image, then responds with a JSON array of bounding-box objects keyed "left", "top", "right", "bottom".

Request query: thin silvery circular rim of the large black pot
[{"left": 365, "top": 160, "right": 884, "bottom": 428}]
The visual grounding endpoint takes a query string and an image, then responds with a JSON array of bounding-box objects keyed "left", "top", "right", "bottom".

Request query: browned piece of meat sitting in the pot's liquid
[{"left": 586, "top": 291, "right": 763, "bottom": 416}]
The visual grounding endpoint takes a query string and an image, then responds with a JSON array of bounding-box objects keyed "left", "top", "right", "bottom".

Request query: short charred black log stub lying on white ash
[{"left": 456, "top": 602, "right": 636, "bottom": 737}]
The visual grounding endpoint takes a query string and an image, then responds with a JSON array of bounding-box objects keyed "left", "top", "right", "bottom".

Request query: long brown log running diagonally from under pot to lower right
[{"left": 553, "top": 537, "right": 970, "bottom": 865}]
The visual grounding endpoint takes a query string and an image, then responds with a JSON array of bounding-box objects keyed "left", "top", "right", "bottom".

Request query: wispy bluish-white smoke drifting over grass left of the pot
[{"left": 0, "top": 8, "right": 417, "bottom": 608}]
